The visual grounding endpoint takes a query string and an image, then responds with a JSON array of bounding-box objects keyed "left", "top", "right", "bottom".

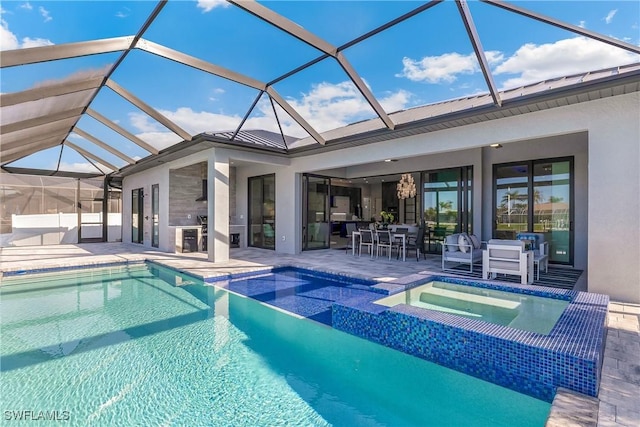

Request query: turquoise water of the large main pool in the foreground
[{"left": 0, "top": 265, "right": 550, "bottom": 427}]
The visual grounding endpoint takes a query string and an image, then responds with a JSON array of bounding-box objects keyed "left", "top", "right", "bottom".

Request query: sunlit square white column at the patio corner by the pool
[{"left": 207, "top": 149, "right": 229, "bottom": 262}]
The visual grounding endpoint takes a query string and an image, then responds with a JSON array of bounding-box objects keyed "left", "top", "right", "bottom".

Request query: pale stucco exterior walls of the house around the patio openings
[{"left": 123, "top": 92, "right": 640, "bottom": 303}]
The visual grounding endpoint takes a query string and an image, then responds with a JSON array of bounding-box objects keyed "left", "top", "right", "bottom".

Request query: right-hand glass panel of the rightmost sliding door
[{"left": 533, "top": 160, "right": 573, "bottom": 264}]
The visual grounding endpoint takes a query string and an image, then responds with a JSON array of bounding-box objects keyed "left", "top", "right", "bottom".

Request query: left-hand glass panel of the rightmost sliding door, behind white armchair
[{"left": 493, "top": 163, "right": 529, "bottom": 240}]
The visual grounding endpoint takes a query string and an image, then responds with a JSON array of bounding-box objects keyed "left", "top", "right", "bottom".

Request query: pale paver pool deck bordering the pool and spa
[{"left": 0, "top": 243, "right": 640, "bottom": 427}]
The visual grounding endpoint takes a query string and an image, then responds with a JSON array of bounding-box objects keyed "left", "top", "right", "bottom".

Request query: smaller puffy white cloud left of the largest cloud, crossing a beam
[{"left": 396, "top": 51, "right": 503, "bottom": 83}]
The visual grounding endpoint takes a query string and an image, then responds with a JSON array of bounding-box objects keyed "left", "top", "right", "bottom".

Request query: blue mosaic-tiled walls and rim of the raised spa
[{"left": 332, "top": 274, "right": 609, "bottom": 402}]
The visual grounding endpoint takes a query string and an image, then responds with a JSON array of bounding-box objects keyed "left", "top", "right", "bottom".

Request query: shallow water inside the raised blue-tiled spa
[{"left": 376, "top": 281, "right": 569, "bottom": 335}]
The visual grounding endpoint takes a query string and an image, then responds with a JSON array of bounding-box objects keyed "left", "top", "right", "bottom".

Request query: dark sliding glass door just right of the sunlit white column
[{"left": 249, "top": 174, "right": 276, "bottom": 249}]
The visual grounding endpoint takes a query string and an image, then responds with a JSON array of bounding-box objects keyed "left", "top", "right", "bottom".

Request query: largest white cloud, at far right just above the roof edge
[{"left": 494, "top": 37, "right": 640, "bottom": 88}]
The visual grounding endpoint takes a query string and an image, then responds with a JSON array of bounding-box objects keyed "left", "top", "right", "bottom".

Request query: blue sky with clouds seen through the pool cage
[{"left": 0, "top": 0, "right": 640, "bottom": 170}]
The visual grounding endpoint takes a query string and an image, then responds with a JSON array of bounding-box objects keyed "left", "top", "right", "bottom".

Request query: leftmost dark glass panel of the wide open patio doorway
[{"left": 302, "top": 175, "right": 331, "bottom": 250}]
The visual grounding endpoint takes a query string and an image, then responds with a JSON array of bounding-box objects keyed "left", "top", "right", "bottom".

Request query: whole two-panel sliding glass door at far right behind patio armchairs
[{"left": 493, "top": 157, "right": 574, "bottom": 265}]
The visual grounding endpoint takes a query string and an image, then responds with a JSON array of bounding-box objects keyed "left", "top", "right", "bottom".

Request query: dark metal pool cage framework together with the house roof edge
[{"left": 0, "top": 0, "right": 640, "bottom": 176}]
